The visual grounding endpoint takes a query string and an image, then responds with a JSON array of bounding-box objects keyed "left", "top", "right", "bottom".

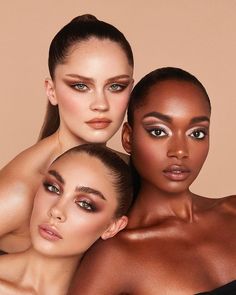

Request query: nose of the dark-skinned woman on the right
[{"left": 167, "top": 136, "right": 189, "bottom": 160}]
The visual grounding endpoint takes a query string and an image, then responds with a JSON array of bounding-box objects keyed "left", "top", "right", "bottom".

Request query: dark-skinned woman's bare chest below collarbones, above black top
[{"left": 122, "top": 220, "right": 236, "bottom": 295}]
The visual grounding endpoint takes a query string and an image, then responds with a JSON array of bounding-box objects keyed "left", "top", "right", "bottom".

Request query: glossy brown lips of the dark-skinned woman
[{"left": 163, "top": 165, "right": 191, "bottom": 181}]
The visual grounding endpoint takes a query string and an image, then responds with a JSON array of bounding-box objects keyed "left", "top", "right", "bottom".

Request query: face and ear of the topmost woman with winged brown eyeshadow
[{"left": 46, "top": 38, "right": 133, "bottom": 144}]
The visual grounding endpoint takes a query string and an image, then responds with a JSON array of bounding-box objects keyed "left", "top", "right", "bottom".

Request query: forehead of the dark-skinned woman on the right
[{"left": 134, "top": 80, "right": 210, "bottom": 117}]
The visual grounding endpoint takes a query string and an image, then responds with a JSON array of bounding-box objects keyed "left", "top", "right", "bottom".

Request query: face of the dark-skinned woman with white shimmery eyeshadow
[{"left": 125, "top": 80, "right": 210, "bottom": 194}]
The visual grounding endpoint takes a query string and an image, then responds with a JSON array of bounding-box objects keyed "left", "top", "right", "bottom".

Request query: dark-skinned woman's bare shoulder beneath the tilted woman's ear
[{"left": 69, "top": 233, "right": 130, "bottom": 295}]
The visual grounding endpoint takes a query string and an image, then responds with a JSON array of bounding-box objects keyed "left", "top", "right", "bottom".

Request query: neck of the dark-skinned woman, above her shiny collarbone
[{"left": 128, "top": 184, "right": 195, "bottom": 228}]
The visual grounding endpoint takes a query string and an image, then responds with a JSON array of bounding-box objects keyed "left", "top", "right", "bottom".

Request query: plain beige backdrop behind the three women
[{"left": 0, "top": 0, "right": 236, "bottom": 197}]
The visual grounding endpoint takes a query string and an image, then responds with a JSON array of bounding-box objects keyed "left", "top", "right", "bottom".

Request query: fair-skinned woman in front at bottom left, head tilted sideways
[{"left": 0, "top": 144, "right": 132, "bottom": 295}]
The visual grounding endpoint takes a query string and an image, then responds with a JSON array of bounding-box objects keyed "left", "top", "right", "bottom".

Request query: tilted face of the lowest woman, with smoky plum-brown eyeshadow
[{"left": 30, "top": 153, "right": 118, "bottom": 256}]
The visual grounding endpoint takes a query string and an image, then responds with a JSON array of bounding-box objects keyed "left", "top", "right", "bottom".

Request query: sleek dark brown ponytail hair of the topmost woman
[{"left": 39, "top": 14, "right": 134, "bottom": 140}]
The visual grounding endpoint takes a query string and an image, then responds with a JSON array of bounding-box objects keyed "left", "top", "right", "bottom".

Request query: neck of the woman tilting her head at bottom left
[{"left": 22, "top": 248, "right": 81, "bottom": 295}]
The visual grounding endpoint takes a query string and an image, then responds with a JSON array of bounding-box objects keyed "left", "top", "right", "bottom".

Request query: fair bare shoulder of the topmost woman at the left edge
[{"left": 0, "top": 137, "right": 54, "bottom": 238}]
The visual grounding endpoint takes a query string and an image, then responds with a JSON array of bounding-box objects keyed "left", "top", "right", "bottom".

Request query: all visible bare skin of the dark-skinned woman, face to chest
[{"left": 69, "top": 81, "right": 236, "bottom": 295}]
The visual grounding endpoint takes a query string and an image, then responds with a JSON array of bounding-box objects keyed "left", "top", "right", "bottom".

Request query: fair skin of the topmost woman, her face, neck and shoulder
[{"left": 0, "top": 38, "right": 133, "bottom": 253}]
